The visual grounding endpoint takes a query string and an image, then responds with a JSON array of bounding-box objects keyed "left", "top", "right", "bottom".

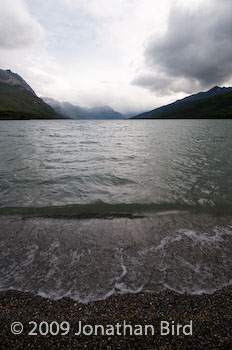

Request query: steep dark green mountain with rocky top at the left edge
[{"left": 0, "top": 69, "right": 62, "bottom": 119}]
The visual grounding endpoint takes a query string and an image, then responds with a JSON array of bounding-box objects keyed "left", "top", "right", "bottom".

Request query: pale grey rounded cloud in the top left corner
[{"left": 0, "top": 0, "right": 44, "bottom": 49}]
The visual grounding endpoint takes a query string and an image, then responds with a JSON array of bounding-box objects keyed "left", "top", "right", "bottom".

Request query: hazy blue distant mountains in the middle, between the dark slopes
[{"left": 42, "top": 97, "right": 125, "bottom": 119}]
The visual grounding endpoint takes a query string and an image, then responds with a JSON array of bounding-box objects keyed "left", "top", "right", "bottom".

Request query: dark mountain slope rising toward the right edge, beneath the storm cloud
[{"left": 132, "top": 86, "right": 232, "bottom": 119}]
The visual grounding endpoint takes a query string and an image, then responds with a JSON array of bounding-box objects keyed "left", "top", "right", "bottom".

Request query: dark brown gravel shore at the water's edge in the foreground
[{"left": 0, "top": 287, "right": 232, "bottom": 350}]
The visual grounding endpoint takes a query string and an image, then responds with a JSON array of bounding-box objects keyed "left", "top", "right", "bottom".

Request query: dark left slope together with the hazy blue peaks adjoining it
[{"left": 0, "top": 69, "right": 124, "bottom": 119}]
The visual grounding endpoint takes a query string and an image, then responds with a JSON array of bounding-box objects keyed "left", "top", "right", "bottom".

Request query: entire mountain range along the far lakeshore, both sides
[{"left": 0, "top": 69, "right": 232, "bottom": 119}]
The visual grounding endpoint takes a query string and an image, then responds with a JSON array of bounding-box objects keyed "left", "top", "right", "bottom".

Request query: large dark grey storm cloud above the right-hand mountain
[{"left": 133, "top": 0, "right": 232, "bottom": 93}]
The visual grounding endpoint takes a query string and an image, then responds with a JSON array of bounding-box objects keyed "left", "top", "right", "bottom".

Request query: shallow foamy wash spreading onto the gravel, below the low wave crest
[{"left": 0, "top": 212, "right": 232, "bottom": 302}]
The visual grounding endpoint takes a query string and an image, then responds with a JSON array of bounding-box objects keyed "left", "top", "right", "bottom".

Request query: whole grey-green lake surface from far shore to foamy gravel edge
[{"left": 0, "top": 120, "right": 232, "bottom": 302}]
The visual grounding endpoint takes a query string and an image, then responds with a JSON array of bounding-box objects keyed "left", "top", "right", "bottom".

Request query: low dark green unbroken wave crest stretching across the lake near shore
[{"left": 0, "top": 201, "right": 232, "bottom": 219}]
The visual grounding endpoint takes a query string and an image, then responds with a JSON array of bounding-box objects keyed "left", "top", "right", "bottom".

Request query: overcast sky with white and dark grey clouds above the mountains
[{"left": 0, "top": 0, "right": 232, "bottom": 114}]
